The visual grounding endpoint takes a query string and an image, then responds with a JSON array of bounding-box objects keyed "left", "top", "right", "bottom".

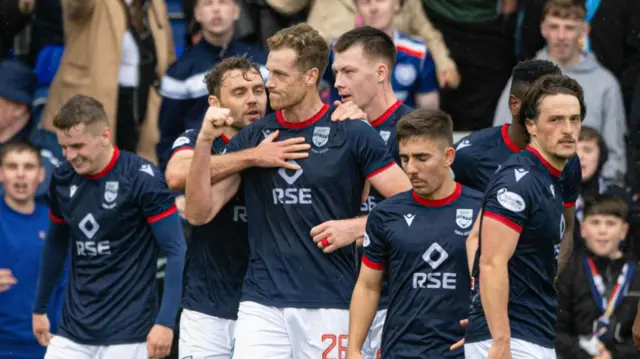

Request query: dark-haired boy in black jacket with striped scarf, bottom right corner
[{"left": 556, "top": 195, "right": 640, "bottom": 359}]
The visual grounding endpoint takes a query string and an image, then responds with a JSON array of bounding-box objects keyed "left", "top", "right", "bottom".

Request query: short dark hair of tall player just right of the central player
[{"left": 333, "top": 26, "right": 396, "bottom": 70}]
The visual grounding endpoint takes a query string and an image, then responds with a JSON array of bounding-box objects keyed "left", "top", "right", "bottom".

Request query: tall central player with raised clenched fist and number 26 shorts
[{"left": 186, "top": 24, "right": 410, "bottom": 359}]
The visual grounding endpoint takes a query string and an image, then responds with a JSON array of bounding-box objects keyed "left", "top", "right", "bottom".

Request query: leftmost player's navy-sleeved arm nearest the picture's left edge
[{"left": 32, "top": 218, "right": 70, "bottom": 346}]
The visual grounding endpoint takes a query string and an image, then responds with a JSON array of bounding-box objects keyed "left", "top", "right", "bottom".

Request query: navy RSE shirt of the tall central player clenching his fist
[{"left": 227, "top": 105, "right": 393, "bottom": 309}]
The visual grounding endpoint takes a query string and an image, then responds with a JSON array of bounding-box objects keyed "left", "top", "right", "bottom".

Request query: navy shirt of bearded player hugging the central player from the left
[{"left": 171, "top": 130, "right": 249, "bottom": 320}]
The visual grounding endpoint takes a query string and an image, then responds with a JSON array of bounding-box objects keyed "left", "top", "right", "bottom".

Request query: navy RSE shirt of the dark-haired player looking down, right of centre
[{"left": 362, "top": 184, "right": 482, "bottom": 358}]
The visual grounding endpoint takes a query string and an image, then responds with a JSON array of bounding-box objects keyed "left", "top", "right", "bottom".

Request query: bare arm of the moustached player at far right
[{"left": 479, "top": 217, "right": 520, "bottom": 358}]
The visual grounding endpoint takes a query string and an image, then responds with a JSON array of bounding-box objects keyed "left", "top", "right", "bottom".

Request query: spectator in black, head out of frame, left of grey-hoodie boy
[{"left": 423, "top": 0, "right": 517, "bottom": 131}]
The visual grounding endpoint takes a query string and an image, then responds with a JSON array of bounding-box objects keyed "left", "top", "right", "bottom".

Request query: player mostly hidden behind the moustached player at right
[{"left": 451, "top": 60, "right": 582, "bottom": 278}]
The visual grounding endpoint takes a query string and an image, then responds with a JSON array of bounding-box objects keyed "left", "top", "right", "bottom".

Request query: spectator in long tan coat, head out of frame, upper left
[{"left": 42, "top": 0, "right": 174, "bottom": 162}]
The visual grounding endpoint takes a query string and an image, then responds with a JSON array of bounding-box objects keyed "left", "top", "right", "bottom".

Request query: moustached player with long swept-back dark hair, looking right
[{"left": 465, "top": 75, "right": 585, "bottom": 359}]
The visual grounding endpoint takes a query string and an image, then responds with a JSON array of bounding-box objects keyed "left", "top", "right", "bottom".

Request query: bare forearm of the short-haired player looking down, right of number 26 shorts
[{"left": 347, "top": 264, "right": 384, "bottom": 359}]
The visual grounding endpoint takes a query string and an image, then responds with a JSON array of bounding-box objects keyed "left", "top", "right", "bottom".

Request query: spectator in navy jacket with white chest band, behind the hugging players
[{"left": 157, "top": 0, "right": 266, "bottom": 168}]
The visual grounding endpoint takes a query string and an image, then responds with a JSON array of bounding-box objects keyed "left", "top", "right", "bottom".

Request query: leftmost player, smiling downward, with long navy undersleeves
[{"left": 33, "top": 95, "right": 185, "bottom": 359}]
